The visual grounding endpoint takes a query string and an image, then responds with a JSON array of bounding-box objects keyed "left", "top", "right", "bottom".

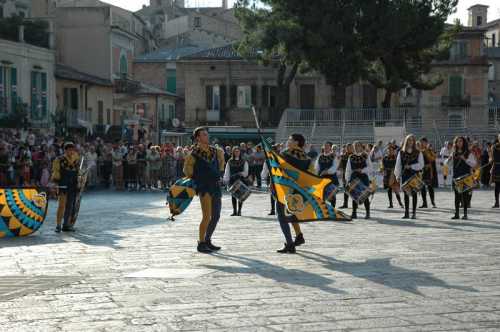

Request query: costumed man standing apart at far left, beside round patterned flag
[{"left": 51, "top": 142, "right": 80, "bottom": 233}]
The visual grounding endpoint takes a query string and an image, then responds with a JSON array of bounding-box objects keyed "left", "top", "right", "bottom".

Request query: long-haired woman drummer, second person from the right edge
[{"left": 448, "top": 136, "right": 477, "bottom": 219}]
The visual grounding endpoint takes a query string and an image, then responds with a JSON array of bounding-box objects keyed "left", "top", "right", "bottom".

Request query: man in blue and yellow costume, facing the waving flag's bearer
[{"left": 184, "top": 127, "right": 225, "bottom": 253}]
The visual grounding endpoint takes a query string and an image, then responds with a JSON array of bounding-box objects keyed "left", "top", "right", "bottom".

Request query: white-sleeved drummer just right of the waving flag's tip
[{"left": 345, "top": 141, "right": 372, "bottom": 219}]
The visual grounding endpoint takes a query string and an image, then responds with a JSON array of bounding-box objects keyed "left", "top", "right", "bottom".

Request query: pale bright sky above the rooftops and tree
[{"left": 102, "top": 0, "right": 500, "bottom": 24}]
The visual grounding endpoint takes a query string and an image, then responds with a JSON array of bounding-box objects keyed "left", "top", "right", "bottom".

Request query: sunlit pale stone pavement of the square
[{"left": 0, "top": 191, "right": 500, "bottom": 332}]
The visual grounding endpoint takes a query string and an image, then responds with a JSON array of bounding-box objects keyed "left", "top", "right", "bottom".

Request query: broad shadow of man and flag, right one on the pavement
[{"left": 297, "top": 251, "right": 477, "bottom": 296}]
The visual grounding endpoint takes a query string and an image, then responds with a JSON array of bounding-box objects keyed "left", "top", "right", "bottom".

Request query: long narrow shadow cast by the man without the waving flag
[{"left": 202, "top": 253, "right": 345, "bottom": 294}]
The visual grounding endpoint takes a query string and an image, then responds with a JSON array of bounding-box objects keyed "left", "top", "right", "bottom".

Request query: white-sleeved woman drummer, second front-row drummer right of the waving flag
[{"left": 394, "top": 135, "right": 424, "bottom": 219}]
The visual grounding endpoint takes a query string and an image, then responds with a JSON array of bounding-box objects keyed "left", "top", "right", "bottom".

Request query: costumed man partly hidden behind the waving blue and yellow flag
[{"left": 276, "top": 134, "right": 314, "bottom": 254}]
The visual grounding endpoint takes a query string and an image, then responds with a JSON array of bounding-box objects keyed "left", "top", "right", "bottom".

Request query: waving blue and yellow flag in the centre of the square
[{"left": 262, "top": 140, "right": 351, "bottom": 222}]
